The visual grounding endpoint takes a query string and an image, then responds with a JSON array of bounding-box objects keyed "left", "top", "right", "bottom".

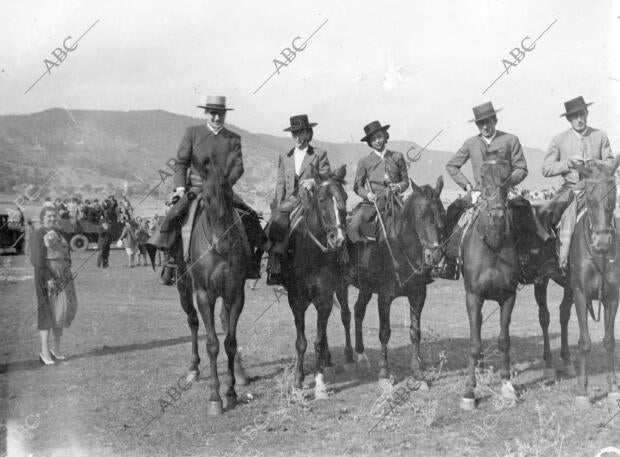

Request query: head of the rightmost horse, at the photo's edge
[{"left": 576, "top": 156, "right": 620, "bottom": 253}]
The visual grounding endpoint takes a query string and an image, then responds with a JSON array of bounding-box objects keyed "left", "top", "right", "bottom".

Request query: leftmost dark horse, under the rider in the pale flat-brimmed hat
[{"left": 173, "top": 162, "right": 250, "bottom": 415}]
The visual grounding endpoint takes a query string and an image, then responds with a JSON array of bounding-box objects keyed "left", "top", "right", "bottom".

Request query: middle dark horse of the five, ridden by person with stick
[{"left": 336, "top": 176, "right": 445, "bottom": 378}]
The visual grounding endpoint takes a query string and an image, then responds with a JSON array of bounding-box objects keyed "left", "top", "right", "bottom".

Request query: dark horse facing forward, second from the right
[{"left": 461, "top": 159, "right": 520, "bottom": 409}]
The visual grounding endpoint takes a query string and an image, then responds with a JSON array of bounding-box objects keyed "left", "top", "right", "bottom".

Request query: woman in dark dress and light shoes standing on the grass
[{"left": 30, "top": 207, "right": 77, "bottom": 365}]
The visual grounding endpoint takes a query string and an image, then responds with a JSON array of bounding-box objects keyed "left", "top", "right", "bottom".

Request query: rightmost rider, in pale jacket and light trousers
[{"left": 541, "top": 97, "right": 614, "bottom": 271}]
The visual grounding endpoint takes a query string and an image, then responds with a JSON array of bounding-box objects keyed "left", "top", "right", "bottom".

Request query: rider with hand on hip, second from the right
[{"left": 446, "top": 102, "right": 540, "bottom": 278}]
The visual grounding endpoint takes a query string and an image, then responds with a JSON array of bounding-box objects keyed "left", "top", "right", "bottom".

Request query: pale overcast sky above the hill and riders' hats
[{"left": 0, "top": 0, "right": 620, "bottom": 151}]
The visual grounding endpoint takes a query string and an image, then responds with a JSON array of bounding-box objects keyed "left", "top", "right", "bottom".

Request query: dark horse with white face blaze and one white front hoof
[{"left": 282, "top": 165, "right": 347, "bottom": 398}]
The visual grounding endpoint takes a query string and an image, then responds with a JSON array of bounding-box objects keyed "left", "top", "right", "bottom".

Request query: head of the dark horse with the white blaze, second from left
[{"left": 299, "top": 165, "right": 347, "bottom": 250}]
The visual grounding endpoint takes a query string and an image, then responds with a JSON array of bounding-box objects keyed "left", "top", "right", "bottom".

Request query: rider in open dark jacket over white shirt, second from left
[{"left": 267, "top": 114, "right": 331, "bottom": 285}]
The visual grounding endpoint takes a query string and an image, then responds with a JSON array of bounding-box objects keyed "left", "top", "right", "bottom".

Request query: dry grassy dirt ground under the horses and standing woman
[{"left": 0, "top": 251, "right": 620, "bottom": 457}]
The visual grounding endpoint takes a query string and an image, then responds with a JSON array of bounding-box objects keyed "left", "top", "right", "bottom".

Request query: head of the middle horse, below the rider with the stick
[{"left": 402, "top": 176, "right": 446, "bottom": 265}]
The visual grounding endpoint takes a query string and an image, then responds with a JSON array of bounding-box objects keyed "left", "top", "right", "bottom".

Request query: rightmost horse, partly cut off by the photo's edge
[{"left": 568, "top": 156, "right": 620, "bottom": 406}]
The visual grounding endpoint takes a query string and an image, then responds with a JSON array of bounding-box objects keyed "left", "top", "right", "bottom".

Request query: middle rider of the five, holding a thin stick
[{"left": 348, "top": 121, "right": 409, "bottom": 251}]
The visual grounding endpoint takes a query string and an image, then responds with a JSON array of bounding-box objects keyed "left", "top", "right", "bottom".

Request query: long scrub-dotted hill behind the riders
[{"left": 0, "top": 108, "right": 550, "bottom": 214}]
